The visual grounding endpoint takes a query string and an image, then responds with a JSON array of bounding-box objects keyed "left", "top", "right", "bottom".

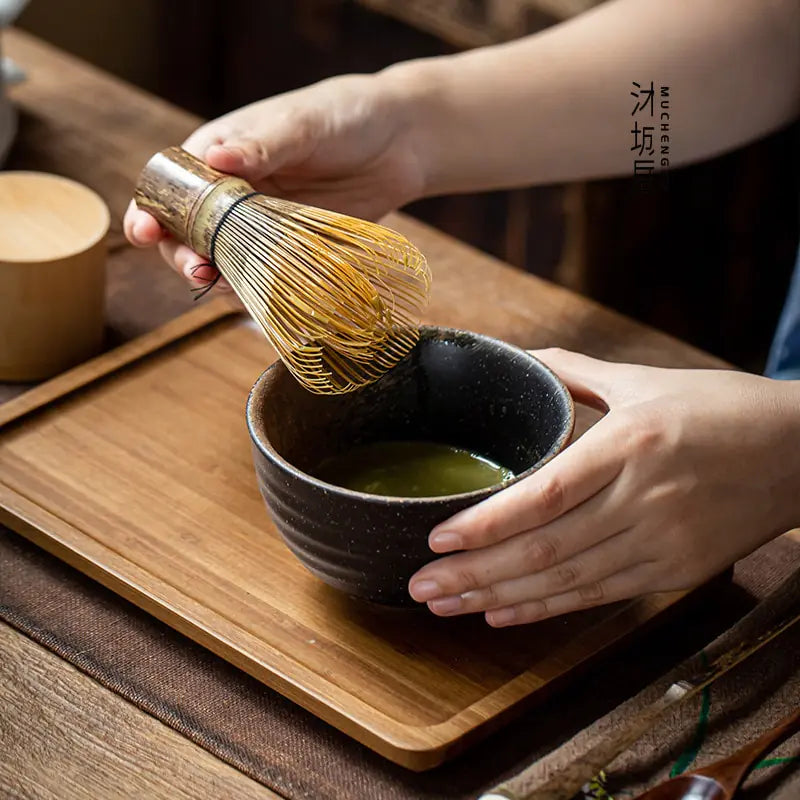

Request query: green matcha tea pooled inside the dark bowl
[{"left": 316, "top": 442, "right": 514, "bottom": 497}]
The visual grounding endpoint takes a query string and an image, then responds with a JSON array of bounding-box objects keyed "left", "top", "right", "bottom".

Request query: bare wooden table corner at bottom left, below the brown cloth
[{"left": 0, "top": 622, "right": 278, "bottom": 800}]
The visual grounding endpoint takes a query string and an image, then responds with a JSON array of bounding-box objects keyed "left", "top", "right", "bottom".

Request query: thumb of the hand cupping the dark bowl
[{"left": 530, "top": 347, "right": 637, "bottom": 411}]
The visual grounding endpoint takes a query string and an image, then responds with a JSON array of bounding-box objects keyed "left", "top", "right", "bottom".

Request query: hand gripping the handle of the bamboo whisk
[{"left": 124, "top": 73, "right": 432, "bottom": 285}]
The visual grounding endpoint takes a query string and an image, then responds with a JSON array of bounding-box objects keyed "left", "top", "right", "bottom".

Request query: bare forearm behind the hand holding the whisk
[{"left": 382, "top": 0, "right": 800, "bottom": 194}]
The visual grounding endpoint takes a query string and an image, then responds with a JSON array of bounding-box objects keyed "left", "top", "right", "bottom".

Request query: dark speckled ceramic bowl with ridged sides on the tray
[{"left": 247, "top": 327, "right": 574, "bottom": 605}]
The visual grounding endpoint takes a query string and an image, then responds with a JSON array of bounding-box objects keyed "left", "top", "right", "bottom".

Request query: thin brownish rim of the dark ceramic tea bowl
[{"left": 246, "top": 325, "right": 575, "bottom": 506}]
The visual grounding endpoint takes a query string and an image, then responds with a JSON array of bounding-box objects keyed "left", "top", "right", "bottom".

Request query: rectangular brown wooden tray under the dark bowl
[{"left": 0, "top": 300, "right": 683, "bottom": 770}]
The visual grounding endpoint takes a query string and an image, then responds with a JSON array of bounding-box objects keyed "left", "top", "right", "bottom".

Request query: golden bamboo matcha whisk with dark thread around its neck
[{"left": 135, "top": 147, "right": 430, "bottom": 394}]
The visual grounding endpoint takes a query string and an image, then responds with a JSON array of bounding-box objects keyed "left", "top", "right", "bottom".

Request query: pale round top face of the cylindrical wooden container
[{"left": 0, "top": 172, "right": 110, "bottom": 262}]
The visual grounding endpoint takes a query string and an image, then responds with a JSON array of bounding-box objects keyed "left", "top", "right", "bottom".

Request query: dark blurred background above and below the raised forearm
[{"left": 14, "top": 0, "right": 800, "bottom": 370}]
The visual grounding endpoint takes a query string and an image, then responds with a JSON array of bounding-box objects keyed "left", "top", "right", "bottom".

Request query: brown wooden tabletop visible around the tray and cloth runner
[{"left": 0, "top": 31, "right": 732, "bottom": 800}]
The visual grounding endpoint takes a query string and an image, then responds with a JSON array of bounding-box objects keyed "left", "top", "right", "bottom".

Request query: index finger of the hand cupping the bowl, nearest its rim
[{"left": 429, "top": 417, "right": 624, "bottom": 553}]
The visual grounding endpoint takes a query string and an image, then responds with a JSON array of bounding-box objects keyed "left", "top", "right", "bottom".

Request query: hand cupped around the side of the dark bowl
[{"left": 410, "top": 350, "right": 800, "bottom": 627}]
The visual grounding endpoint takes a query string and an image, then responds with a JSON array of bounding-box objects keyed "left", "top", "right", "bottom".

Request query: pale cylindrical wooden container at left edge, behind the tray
[{"left": 0, "top": 171, "right": 110, "bottom": 381}]
